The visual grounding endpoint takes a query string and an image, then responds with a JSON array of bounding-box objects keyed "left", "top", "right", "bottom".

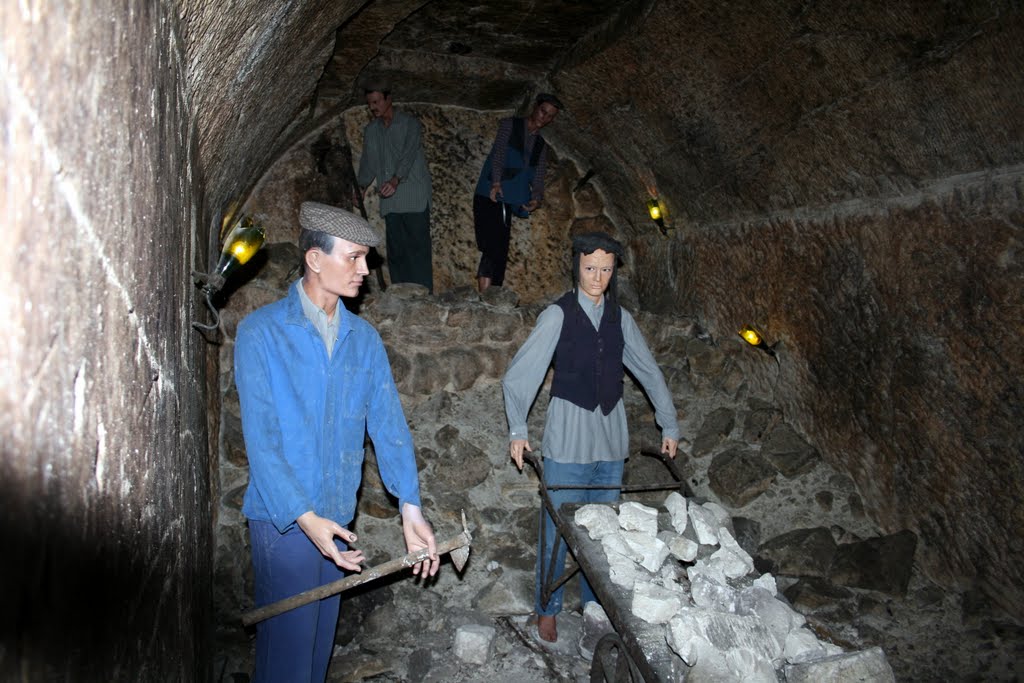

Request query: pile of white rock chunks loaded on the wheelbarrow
[{"left": 574, "top": 492, "right": 894, "bottom": 683}]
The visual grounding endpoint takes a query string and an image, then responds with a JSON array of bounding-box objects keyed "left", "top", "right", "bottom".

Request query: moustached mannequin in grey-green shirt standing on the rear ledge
[{"left": 356, "top": 82, "right": 434, "bottom": 292}]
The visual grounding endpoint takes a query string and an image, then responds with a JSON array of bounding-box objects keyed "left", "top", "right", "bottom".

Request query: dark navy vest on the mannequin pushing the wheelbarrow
[{"left": 551, "top": 292, "right": 626, "bottom": 415}]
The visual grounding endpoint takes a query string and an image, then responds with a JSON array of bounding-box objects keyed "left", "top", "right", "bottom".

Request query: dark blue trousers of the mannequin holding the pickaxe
[{"left": 249, "top": 519, "right": 347, "bottom": 683}]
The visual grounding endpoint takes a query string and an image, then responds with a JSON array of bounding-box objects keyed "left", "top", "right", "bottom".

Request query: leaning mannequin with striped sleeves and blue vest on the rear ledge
[{"left": 473, "top": 93, "right": 562, "bottom": 292}]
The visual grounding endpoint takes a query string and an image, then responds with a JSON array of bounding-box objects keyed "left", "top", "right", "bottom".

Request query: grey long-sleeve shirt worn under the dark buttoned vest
[{"left": 502, "top": 292, "right": 679, "bottom": 464}]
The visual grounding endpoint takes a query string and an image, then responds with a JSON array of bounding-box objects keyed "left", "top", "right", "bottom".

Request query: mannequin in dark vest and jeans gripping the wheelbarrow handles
[{"left": 502, "top": 232, "right": 679, "bottom": 641}]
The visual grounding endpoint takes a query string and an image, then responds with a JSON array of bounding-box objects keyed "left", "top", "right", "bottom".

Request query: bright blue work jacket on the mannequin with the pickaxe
[{"left": 234, "top": 281, "right": 420, "bottom": 532}]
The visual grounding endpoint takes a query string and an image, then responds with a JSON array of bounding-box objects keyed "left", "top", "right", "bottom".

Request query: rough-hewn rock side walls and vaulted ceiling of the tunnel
[{"left": 0, "top": 0, "right": 1024, "bottom": 680}]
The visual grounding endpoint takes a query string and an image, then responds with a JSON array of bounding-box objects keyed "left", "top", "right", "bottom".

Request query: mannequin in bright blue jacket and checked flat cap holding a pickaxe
[{"left": 234, "top": 202, "right": 439, "bottom": 683}]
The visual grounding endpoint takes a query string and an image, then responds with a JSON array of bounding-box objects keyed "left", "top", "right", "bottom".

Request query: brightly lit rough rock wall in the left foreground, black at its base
[{"left": 0, "top": 3, "right": 212, "bottom": 681}]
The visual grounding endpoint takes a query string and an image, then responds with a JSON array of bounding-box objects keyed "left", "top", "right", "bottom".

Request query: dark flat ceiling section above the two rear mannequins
[{"left": 316, "top": 0, "right": 653, "bottom": 110}]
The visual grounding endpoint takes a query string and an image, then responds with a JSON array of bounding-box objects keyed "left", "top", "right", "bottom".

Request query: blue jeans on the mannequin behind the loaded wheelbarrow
[{"left": 534, "top": 458, "right": 626, "bottom": 616}]
